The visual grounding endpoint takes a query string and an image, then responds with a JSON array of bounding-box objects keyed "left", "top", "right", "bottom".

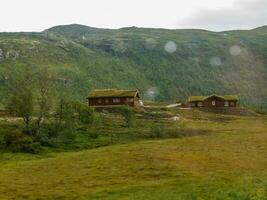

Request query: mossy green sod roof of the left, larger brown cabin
[{"left": 88, "top": 89, "right": 140, "bottom": 98}]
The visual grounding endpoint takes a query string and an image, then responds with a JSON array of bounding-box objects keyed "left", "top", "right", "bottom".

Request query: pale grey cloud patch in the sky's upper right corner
[{"left": 178, "top": 0, "right": 267, "bottom": 30}]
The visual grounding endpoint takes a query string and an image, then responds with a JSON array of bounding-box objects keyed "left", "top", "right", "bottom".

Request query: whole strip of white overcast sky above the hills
[{"left": 0, "top": 0, "right": 267, "bottom": 31}]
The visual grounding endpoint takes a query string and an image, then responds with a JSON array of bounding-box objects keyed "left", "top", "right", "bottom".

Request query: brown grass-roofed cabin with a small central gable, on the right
[{"left": 188, "top": 94, "right": 239, "bottom": 108}]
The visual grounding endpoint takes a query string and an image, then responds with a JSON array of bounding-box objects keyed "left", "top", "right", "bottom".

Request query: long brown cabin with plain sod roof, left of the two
[{"left": 87, "top": 89, "right": 140, "bottom": 107}]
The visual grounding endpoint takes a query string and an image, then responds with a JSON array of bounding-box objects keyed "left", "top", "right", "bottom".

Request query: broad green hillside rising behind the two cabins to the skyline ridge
[{"left": 0, "top": 25, "right": 267, "bottom": 106}]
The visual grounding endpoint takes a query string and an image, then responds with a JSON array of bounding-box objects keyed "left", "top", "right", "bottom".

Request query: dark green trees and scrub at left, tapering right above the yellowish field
[{"left": 1, "top": 68, "right": 219, "bottom": 154}]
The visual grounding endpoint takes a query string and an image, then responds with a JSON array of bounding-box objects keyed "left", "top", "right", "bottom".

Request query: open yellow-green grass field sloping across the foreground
[{"left": 0, "top": 109, "right": 267, "bottom": 200}]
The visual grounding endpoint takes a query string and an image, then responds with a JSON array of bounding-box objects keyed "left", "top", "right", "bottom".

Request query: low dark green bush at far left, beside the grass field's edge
[{"left": 3, "top": 131, "right": 40, "bottom": 153}]
